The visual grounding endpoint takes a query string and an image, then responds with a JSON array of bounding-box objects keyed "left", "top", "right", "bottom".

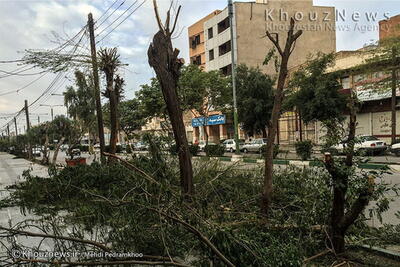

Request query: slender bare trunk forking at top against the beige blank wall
[{"left": 261, "top": 18, "right": 303, "bottom": 216}]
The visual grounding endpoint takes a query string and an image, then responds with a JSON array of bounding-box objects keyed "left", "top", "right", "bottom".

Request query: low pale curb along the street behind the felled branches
[{"left": 193, "top": 157, "right": 394, "bottom": 172}]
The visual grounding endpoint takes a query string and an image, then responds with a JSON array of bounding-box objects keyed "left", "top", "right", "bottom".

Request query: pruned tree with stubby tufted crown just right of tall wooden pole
[{"left": 98, "top": 48, "right": 123, "bottom": 154}]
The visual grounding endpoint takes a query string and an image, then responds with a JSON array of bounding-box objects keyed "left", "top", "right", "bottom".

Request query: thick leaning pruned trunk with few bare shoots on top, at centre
[{"left": 147, "top": 0, "right": 194, "bottom": 196}]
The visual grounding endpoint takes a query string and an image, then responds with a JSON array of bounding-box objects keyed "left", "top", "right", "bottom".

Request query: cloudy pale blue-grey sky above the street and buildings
[{"left": 0, "top": 0, "right": 400, "bottom": 132}]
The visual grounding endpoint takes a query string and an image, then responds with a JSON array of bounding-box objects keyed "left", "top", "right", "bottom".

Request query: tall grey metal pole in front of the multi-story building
[{"left": 228, "top": 0, "right": 240, "bottom": 155}]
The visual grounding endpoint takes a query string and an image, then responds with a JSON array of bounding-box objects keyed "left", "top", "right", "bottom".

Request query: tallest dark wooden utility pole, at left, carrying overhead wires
[{"left": 88, "top": 13, "right": 105, "bottom": 163}]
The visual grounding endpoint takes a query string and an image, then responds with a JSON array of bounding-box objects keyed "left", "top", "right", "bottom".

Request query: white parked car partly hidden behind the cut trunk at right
[{"left": 334, "top": 135, "right": 387, "bottom": 155}]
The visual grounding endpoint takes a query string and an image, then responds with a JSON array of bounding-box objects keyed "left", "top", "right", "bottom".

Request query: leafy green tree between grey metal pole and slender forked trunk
[{"left": 236, "top": 65, "right": 274, "bottom": 138}]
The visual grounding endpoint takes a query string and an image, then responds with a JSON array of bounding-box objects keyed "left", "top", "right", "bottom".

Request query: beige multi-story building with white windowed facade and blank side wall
[{"left": 189, "top": 0, "right": 336, "bottom": 142}]
